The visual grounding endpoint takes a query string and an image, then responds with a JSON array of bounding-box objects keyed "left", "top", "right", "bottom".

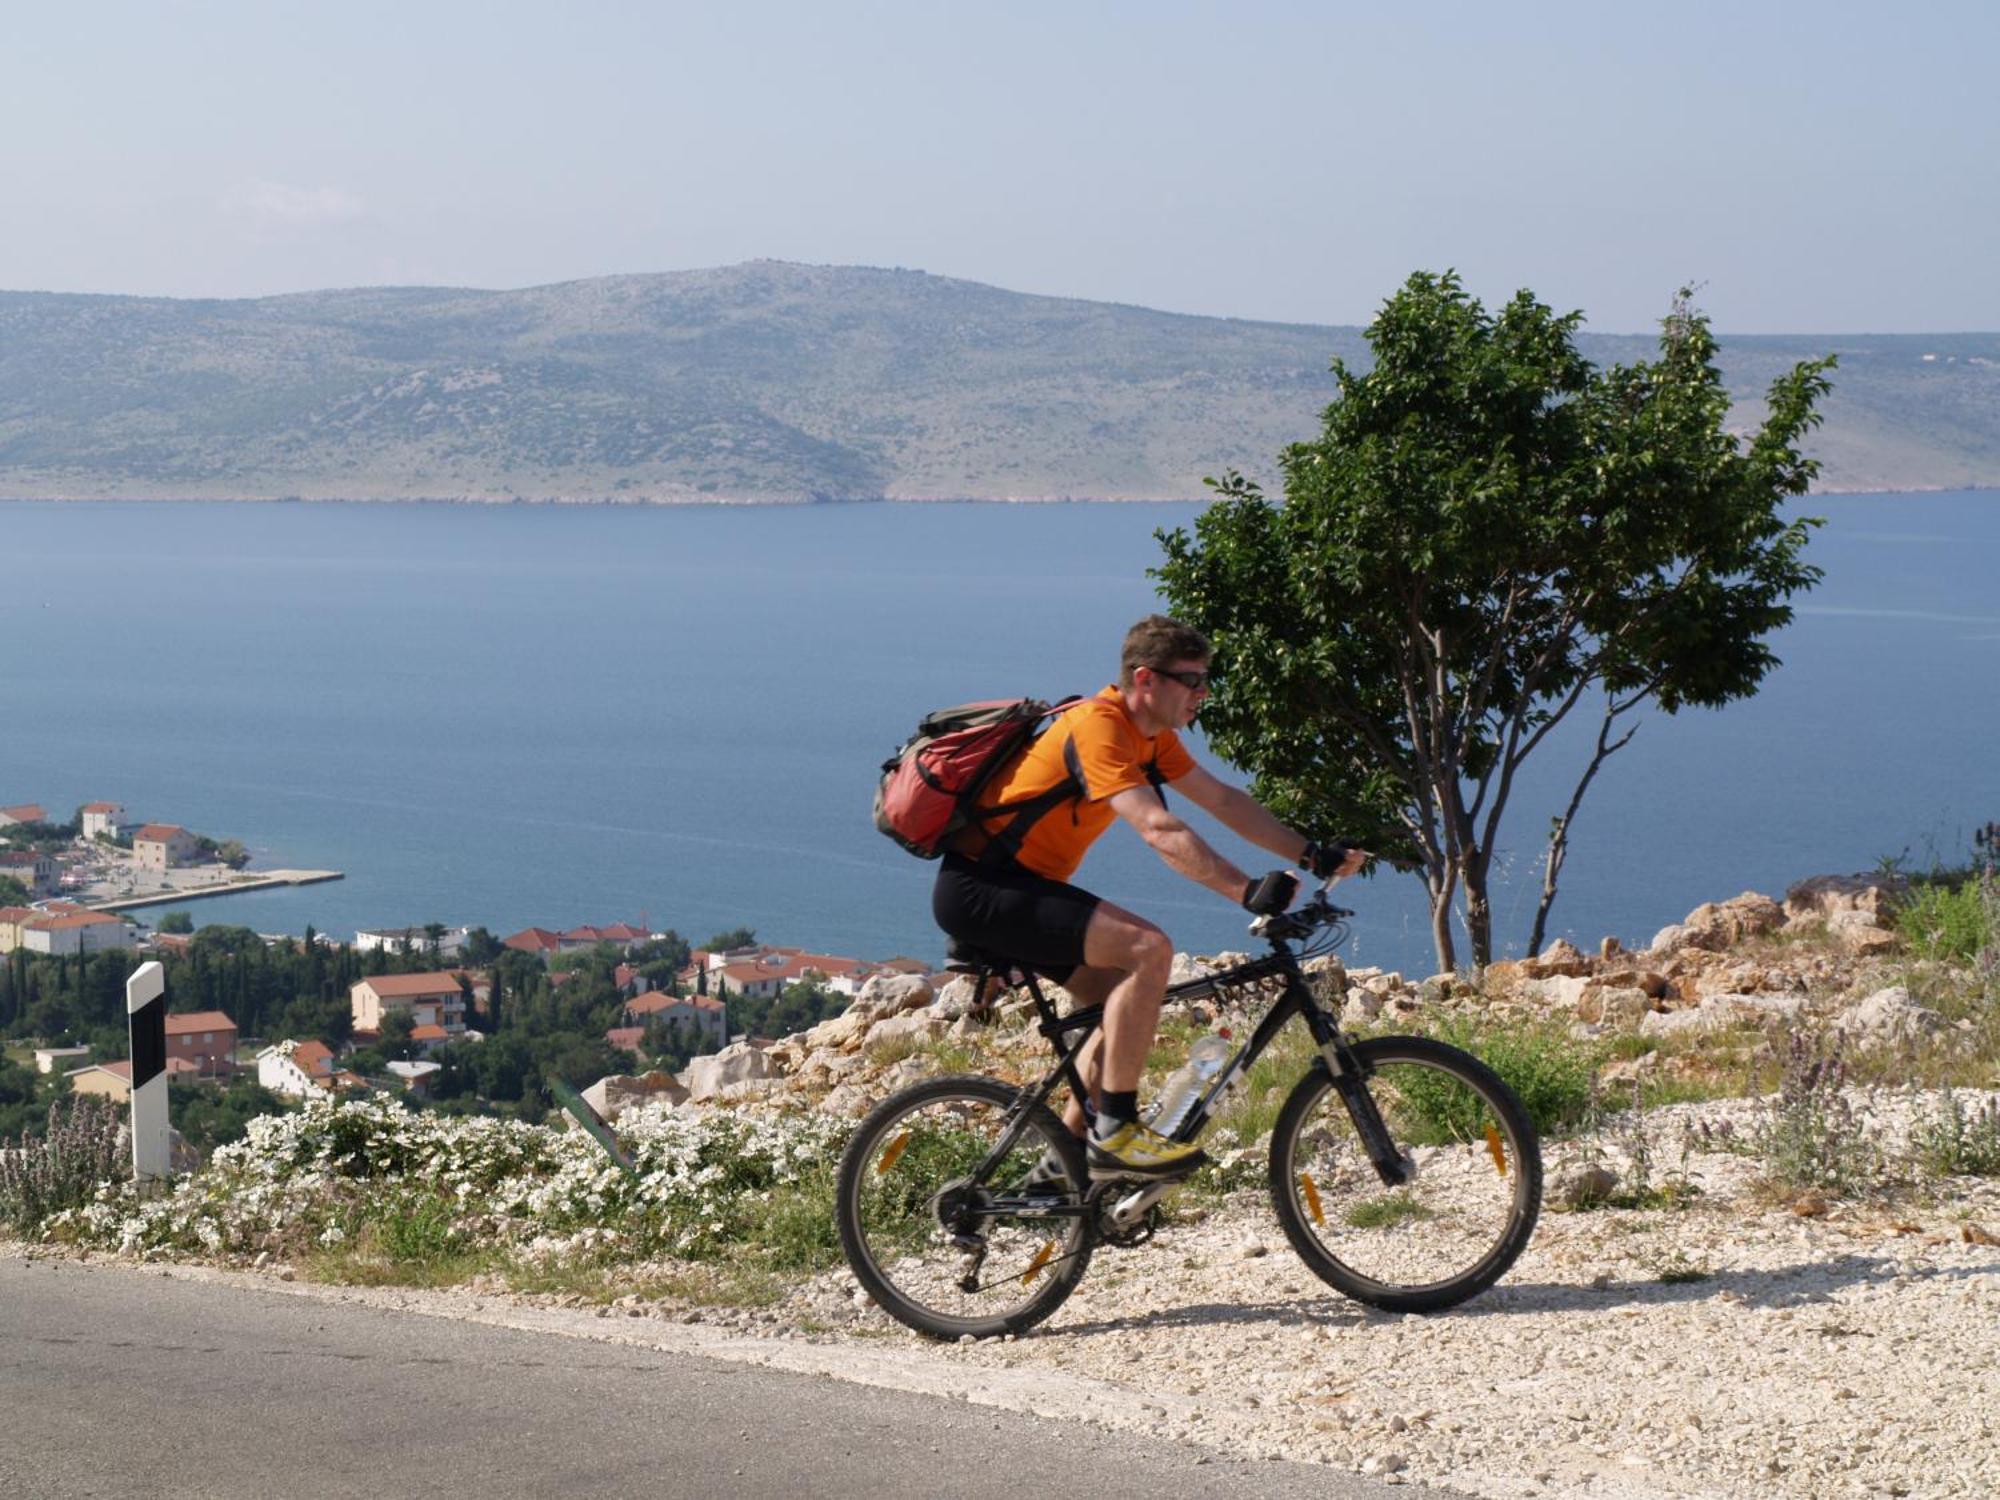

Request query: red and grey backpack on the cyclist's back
[{"left": 874, "top": 698, "right": 1082, "bottom": 860}]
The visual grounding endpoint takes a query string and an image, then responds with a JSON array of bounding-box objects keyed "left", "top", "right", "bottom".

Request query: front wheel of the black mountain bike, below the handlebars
[{"left": 1270, "top": 1036, "right": 1542, "bottom": 1312}]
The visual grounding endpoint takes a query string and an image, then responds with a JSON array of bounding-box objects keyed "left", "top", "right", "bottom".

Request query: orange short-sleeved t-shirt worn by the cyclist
[{"left": 962, "top": 686, "right": 1194, "bottom": 880}]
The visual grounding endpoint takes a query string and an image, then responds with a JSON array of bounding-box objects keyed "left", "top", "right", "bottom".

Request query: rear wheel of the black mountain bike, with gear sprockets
[{"left": 836, "top": 1076, "right": 1094, "bottom": 1338}]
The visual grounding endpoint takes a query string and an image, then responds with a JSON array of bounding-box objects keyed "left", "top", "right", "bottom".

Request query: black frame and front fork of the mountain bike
[{"left": 970, "top": 938, "right": 1410, "bottom": 1218}]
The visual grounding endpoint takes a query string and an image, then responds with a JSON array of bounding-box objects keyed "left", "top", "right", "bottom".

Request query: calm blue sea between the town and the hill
[{"left": 0, "top": 492, "right": 2000, "bottom": 974}]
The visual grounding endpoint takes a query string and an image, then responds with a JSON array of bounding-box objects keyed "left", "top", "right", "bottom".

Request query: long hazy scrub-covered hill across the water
[{"left": 0, "top": 260, "right": 2000, "bottom": 502}]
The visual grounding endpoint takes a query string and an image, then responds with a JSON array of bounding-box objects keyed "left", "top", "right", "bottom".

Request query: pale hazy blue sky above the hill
[{"left": 0, "top": 0, "right": 2000, "bottom": 332}]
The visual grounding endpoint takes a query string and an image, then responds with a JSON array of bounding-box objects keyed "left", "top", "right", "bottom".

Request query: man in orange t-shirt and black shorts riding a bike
[{"left": 932, "top": 614, "right": 1368, "bottom": 1180}]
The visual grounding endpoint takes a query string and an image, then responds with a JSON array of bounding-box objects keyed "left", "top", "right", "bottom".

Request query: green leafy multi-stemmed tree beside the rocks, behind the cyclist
[{"left": 1156, "top": 274, "right": 1832, "bottom": 968}]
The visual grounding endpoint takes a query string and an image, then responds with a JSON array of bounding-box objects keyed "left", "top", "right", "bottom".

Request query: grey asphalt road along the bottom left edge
[{"left": 0, "top": 1256, "right": 1442, "bottom": 1500}]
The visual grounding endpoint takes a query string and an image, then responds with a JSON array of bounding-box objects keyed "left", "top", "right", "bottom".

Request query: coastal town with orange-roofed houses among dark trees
[{"left": 0, "top": 802, "right": 930, "bottom": 1144}]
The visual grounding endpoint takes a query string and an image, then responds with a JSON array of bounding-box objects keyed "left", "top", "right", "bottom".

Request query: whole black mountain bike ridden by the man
[{"left": 834, "top": 880, "right": 1542, "bottom": 1338}]
